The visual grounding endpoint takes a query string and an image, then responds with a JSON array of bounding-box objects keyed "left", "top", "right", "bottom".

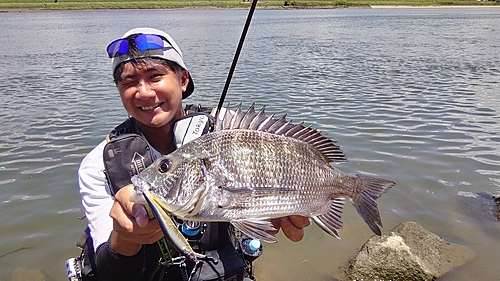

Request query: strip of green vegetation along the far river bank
[{"left": 0, "top": 0, "right": 500, "bottom": 11}]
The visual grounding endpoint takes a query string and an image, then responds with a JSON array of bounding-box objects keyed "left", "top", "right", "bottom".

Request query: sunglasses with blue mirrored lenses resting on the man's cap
[{"left": 107, "top": 34, "right": 179, "bottom": 58}]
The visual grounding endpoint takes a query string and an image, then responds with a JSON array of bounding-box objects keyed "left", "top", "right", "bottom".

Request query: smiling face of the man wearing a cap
[{"left": 116, "top": 63, "right": 189, "bottom": 128}]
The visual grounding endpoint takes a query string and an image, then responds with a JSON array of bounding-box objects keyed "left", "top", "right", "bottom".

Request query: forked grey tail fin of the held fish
[{"left": 351, "top": 175, "right": 396, "bottom": 235}]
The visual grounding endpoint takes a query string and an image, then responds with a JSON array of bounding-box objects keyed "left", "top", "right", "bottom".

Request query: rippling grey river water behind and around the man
[{"left": 0, "top": 8, "right": 500, "bottom": 280}]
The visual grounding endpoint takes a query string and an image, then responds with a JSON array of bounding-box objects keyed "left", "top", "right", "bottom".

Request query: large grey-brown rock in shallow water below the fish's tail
[{"left": 346, "top": 222, "right": 475, "bottom": 281}]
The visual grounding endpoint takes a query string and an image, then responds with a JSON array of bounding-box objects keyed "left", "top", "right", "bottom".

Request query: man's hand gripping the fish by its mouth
[{"left": 109, "top": 185, "right": 163, "bottom": 256}]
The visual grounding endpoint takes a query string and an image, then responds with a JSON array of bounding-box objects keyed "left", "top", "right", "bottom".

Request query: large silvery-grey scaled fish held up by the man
[{"left": 131, "top": 104, "right": 395, "bottom": 243}]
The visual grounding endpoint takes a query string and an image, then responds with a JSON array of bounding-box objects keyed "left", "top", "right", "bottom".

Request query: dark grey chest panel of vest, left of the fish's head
[{"left": 103, "top": 134, "right": 153, "bottom": 195}]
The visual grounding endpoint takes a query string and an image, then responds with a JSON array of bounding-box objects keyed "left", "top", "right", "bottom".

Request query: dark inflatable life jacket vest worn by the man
[{"left": 82, "top": 105, "right": 253, "bottom": 281}]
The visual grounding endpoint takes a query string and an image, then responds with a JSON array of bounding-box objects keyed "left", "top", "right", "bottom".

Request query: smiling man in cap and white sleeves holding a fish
[{"left": 79, "top": 28, "right": 309, "bottom": 281}]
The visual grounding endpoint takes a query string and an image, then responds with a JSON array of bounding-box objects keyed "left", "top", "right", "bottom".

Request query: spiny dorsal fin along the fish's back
[{"left": 215, "top": 103, "right": 347, "bottom": 163}]
